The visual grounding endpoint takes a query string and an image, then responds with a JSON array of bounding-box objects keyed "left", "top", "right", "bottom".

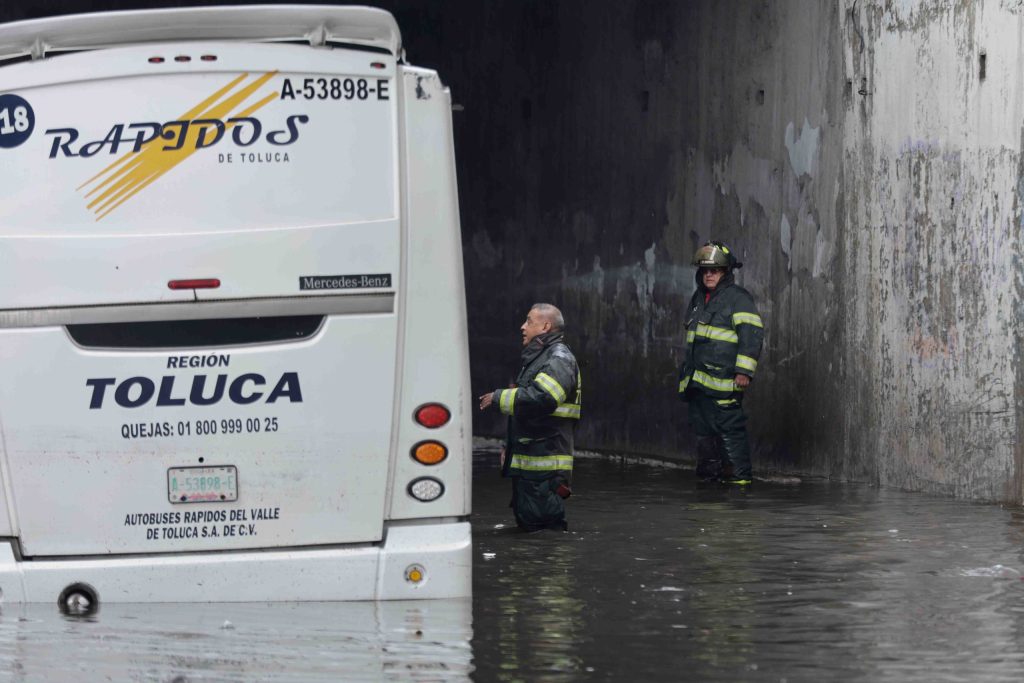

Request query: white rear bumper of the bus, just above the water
[{"left": 0, "top": 521, "right": 472, "bottom": 604}]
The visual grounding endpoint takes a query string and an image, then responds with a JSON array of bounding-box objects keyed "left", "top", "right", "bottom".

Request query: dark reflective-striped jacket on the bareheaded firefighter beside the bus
[{"left": 494, "top": 333, "right": 583, "bottom": 479}]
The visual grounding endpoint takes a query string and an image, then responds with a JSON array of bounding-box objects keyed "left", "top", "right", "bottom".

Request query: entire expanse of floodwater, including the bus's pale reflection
[{"left": 9, "top": 451, "right": 1024, "bottom": 683}]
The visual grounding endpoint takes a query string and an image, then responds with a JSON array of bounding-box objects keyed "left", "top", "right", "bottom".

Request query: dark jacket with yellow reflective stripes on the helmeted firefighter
[{"left": 679, "top": 269, "right": 764, "bottom": 399}]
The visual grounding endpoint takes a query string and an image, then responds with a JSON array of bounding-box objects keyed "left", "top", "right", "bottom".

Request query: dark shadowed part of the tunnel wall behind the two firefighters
[{"left": 385, "top": 1, "right": 847, "bottom": 478}]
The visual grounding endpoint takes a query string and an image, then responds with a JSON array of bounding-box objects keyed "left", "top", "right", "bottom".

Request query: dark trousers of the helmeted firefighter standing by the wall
[{"left": 686, "top": 389, "right": 751, "bottom": 480}]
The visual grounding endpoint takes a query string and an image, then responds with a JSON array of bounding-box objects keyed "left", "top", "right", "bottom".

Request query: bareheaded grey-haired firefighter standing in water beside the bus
[{"left": 480, "top": 303, "right": 582, "bottom": 531}]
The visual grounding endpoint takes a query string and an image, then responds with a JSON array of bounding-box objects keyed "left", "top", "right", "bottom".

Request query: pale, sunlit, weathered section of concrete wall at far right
[{"left": 837, "top": 0, "right": 1024, "bottom": 501}]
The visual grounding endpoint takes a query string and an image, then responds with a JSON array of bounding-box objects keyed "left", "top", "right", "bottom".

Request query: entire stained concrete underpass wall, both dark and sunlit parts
[{"left": 6, "top": 0, "right": 1024, "bottom": 502}]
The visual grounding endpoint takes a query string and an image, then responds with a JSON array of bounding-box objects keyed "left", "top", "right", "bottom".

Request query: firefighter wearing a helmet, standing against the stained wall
[{"left": 679, "top": 242, "right": 764, "bottom": 485}]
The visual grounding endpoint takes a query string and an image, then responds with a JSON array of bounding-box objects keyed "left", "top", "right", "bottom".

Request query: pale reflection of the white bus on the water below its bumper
[{"left": 0, "top": 600, "right": 472, "bottom": 682}]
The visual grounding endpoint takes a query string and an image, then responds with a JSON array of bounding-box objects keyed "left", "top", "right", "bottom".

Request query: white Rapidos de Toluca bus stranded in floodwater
[{"left": 0, "top": 6, "right": 471, "bottom": 605}]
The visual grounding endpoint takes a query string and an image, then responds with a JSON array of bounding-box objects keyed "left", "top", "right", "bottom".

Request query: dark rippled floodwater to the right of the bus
[{"left": 473, "top": 453, "right": 1024, "bottom": 682}]
